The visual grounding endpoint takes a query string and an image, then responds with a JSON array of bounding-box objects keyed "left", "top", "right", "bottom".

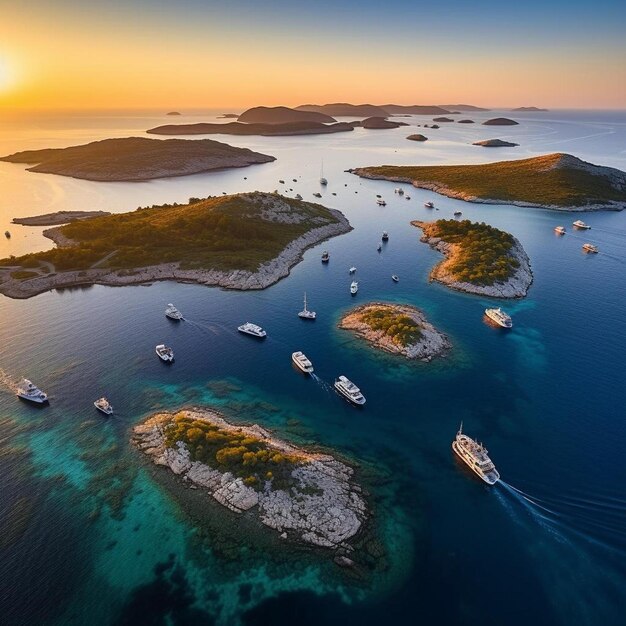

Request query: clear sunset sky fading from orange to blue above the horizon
[{"left": 0, "top": 0, "right": 626, "bottom": 109}]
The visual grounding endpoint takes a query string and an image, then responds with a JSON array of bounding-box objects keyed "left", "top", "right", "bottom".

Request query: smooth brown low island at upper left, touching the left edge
[{"left": 0, "top": 137, "right": 276, "bottom": 182}]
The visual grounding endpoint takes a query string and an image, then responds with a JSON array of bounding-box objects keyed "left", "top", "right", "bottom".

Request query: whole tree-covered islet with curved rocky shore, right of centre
[{"left": 411, "top": 220, "right": 533, "bottom": 298}]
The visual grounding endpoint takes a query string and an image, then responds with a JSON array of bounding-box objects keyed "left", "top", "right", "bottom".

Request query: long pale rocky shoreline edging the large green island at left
[{"left": 0, "top": 209, "right": 352, "bottom": 299}]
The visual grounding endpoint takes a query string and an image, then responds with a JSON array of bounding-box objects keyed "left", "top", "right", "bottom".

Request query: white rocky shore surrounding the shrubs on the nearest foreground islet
[{"left": 131, "top": 408, "right": 368, "bottom": 548}]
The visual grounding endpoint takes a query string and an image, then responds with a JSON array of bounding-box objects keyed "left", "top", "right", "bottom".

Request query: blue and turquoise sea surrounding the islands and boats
[{"left": 0, "top": 111, "right": 626, "bottom": 626}]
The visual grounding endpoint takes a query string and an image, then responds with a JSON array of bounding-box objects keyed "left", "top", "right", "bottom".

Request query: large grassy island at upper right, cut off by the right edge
[{"left": 350, "top": 153, "right": 626, "bottom": 211}]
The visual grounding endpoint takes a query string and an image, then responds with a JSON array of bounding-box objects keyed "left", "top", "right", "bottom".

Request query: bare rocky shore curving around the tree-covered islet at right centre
[{"left": 411, "top": 221, "right": 533, "bottom": 298}]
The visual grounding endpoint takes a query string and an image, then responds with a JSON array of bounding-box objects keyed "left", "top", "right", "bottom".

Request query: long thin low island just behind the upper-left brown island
[{"left": 146, "top": 122, "right": 354, "bottom": 137}]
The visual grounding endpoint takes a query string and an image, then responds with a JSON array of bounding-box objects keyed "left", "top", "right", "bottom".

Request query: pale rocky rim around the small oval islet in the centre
[{"left": 339, "top": 302, "right": 452, "bottom": 361}]
